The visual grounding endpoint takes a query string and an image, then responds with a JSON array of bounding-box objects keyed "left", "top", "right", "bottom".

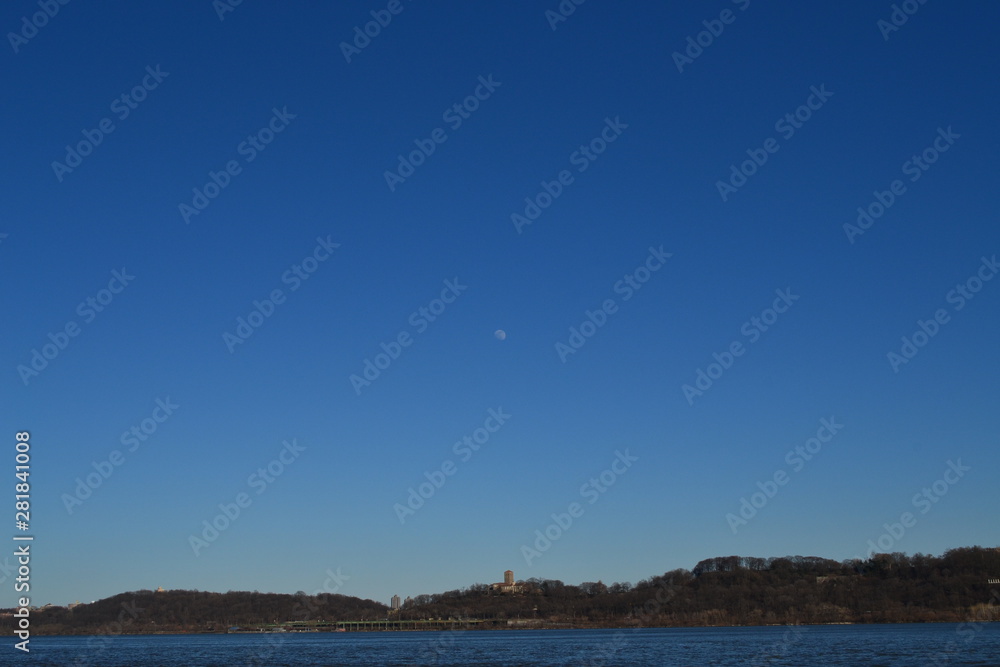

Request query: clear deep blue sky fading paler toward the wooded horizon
[{"left": 0, "top": 0, "right": 1000, "bottom": 605}]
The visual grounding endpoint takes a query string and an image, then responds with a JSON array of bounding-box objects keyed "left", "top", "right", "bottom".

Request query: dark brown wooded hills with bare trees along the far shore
[{"left": 7, "top": 547, "right": 1000, "bottom": 634}]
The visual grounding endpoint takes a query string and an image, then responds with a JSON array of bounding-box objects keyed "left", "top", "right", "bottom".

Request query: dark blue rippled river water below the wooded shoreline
[{"left": 13, "top": 623, "right": 1000, "bottom": 667}]
